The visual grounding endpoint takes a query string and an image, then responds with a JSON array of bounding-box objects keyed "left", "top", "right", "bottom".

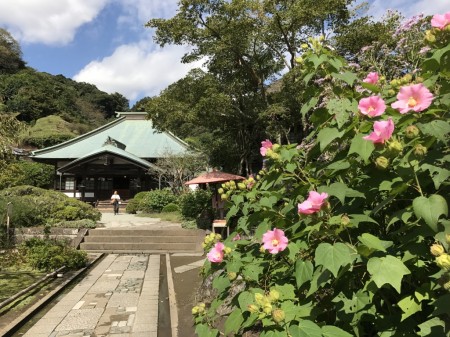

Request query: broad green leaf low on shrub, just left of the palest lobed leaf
[{"left": 314, "top": 242, "right": 356, "bottom": 277}]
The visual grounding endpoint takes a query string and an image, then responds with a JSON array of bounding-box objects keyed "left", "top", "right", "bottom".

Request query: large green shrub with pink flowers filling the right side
[{"left": 194, "top": 13, "right": 450, "bottom": 337}]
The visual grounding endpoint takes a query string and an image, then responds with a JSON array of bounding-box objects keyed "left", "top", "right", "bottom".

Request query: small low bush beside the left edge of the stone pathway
[{"left": 19, "top": 238, "right": 88, "bottom": 271}]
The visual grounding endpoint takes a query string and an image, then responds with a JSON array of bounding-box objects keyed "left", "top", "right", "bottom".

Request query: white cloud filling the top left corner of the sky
[{"left": 0, "top": 0, "right": 107, "bottom": 45}]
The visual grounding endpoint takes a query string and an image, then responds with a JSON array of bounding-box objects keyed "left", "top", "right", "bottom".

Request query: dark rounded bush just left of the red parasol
[{"left": 180, "top": 189, "right": 214, "bottom": 228}]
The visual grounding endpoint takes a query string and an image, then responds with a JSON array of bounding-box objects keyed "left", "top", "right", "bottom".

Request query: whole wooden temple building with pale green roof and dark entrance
[{"left": 30, "top": 112, "right": 189, "bottom": 202}]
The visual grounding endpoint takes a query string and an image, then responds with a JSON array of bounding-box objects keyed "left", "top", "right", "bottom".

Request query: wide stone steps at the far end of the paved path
[{"left": 80, "top": 228, "right": 205, "bottom": 254}]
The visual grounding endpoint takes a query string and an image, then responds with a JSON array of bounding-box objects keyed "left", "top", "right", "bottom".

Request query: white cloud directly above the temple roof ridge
[{"left": 74, "top": 41, "right": 201, "bottom": 101}]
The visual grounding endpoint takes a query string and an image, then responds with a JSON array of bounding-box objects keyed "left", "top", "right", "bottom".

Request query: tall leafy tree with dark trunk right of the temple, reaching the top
[{"left": 147, "top": 0, "right": 353, "bottom": 173}]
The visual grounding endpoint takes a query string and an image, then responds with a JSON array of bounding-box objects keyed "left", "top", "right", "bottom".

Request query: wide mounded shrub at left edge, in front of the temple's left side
[{"left": 0, "top": 185, "right": 101, "bottom": 227}]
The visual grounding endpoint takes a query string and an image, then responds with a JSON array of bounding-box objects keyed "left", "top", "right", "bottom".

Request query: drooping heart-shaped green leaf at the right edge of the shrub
[{"left": 413, "top": 194, "right": 448, "bottom": 232}]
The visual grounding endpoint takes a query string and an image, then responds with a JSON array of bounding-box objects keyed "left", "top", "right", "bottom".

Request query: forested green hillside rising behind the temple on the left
[{"left": 0, "top": 29, "right": 129, "bottom": 147}]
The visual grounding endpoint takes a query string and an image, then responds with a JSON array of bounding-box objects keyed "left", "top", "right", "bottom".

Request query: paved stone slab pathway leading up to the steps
[{"left": 23, "top": 254, "right": 160, "bottom": 337}]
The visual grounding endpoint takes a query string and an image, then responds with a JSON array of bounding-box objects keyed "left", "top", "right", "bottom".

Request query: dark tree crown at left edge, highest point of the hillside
[{"left": 0, "top": 28, "right": 25, "bottom": 74}]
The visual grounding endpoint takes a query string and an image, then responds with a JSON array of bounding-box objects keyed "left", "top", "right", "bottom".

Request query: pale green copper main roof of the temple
[{"left": 31, "top": 112, "right": 188, "bottom": 160}]
